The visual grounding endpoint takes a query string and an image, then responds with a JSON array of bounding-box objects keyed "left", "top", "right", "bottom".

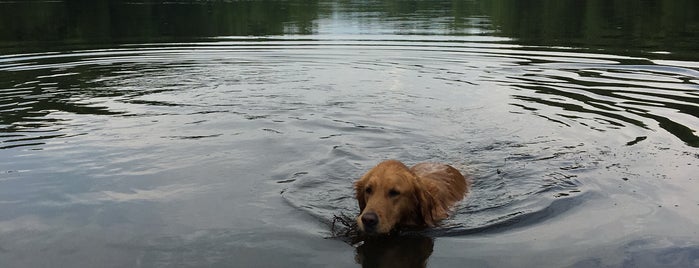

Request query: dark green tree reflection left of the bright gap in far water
[{"left": 0, "top": 0, "right": 327, "bottom": 45}]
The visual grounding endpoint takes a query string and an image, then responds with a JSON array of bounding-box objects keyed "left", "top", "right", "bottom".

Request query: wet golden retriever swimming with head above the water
[{"left": 354, "top": 160, "right": 470, "bottom": 234}]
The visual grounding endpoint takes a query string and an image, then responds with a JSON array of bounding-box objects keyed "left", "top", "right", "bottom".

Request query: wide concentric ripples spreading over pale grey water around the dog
[{"left": 0, "top": 36, "right": 699, "bottom": 235}]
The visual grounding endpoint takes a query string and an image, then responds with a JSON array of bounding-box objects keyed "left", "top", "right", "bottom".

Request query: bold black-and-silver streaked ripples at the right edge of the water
[{"left": 511, "top": 62, "right": 699, "bottom": 147}]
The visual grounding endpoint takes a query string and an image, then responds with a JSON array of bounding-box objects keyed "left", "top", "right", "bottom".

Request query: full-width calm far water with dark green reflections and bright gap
[{"left": 0, "top": 0, "right": 699, "bottom": 59}]
